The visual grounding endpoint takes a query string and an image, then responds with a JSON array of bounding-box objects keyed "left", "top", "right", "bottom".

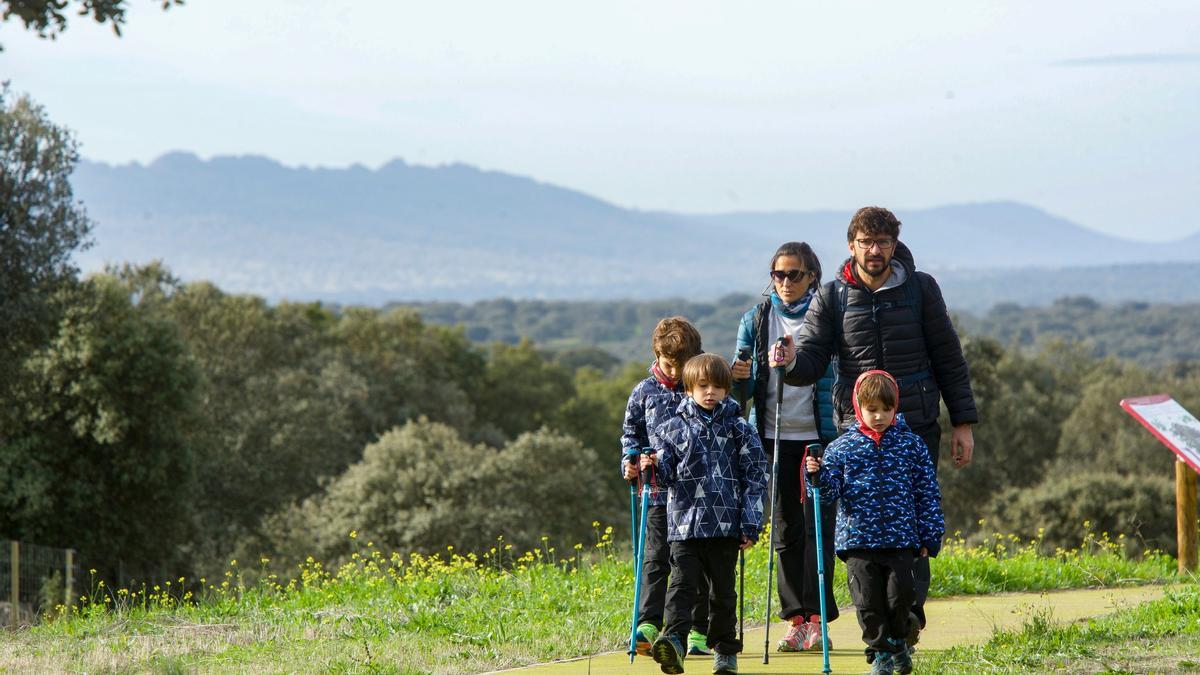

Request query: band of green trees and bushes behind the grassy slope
[{"left": 0, "top": 258, "right": 1200, "bottom": 578}]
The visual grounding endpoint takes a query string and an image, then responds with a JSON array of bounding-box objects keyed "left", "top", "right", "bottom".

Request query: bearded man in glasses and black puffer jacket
[{"left": 770, "top": 207, "right": 979, "bottom": 646}]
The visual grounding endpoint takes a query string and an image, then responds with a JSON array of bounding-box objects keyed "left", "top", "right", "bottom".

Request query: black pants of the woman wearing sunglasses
[{"left": 762, "top": 438, "right": 838, "bottom": 621}]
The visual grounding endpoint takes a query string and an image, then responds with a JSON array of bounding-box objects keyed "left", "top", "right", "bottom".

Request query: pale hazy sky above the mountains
[{"left": 0, "top": 0, "right": 1200, "bottom": 240}]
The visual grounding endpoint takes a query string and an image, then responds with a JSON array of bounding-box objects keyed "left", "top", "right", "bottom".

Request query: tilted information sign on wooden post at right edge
[{"left": 1121, "top": 394, "right": 1200, "bottom": 573}]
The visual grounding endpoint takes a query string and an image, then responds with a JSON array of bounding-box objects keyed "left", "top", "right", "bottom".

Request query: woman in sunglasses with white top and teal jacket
[{"left": 733, "top": 241, "right": 838, "bottom": 651}]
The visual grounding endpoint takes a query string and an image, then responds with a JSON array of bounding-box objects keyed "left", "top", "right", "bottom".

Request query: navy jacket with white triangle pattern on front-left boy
[{"left": 653, "top": 399, "right": 767, "bottom": 542}]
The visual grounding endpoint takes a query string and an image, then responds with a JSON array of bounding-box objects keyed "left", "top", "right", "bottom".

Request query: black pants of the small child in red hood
[{"left": 846, "top": 549, "right": 914, "bottom": 652}]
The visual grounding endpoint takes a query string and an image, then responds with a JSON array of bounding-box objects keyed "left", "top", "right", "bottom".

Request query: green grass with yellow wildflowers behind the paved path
[{"left": 0, "top": 526, "right": 1175, "bottom": 673}]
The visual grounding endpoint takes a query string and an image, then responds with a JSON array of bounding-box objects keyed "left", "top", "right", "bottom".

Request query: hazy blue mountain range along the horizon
[{"left": 72, "top": 153, "right": 1200, "bottom": 306}]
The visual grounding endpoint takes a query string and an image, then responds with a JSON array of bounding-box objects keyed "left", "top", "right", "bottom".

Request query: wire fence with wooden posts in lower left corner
[{"left": 0, "top": 539, "right": 80, "bottom": 627}]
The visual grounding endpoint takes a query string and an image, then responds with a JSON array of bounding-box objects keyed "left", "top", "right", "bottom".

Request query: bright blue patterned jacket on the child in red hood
[{"left": 817, "top": 414, "right": 946, "bottom": 560}]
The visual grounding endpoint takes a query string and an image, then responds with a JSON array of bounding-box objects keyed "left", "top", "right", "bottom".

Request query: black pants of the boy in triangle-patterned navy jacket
[{"left": 665, "top": 537, "right": 742, "bottom": 653}]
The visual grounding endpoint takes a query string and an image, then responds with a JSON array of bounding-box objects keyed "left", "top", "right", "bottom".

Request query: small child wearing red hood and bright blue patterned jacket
[{"left": 805, "top": 370, "right": 946, "bottom": 674}]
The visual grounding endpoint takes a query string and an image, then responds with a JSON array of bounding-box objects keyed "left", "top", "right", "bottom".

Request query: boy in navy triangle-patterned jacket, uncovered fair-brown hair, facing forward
[{"left": 641, "top": 354, "right": 767, "bottom": 675}]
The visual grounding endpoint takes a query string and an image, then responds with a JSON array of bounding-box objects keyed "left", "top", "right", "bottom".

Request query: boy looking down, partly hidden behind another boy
[{"left": 620, "top": 316, "right": 710, "bottom": 656}]
